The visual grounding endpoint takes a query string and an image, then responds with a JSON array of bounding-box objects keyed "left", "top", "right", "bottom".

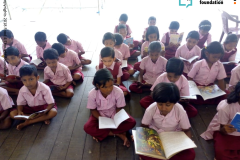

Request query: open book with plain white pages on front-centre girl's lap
[{"left": 99, "top": 109, "right": 129, "bottom": 129}]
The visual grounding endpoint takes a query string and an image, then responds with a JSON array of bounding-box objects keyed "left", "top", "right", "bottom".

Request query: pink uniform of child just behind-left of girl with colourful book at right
[{"left": 175, "top": 44, "right": 201, "bottom": 76}]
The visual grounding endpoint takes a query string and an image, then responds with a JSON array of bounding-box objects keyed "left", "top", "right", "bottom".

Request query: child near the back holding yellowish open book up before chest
[{"left": 161, "top": 21, "right": 180, "bottom": 60}]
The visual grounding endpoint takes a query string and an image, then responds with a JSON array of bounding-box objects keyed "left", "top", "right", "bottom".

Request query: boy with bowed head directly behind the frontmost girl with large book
[{"left": 140, "top": 57, "right": 197, "bottom": 118}]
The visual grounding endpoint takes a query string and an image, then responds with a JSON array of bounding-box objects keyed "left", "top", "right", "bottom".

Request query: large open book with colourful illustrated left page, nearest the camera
[{"left": 133, "top": 127, "right": 197, "bottom": 159}]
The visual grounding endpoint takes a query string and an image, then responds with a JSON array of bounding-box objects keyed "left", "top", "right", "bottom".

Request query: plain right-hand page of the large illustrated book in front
[{"left": 159, "top": 132, "right": 197, "bottom": 159}]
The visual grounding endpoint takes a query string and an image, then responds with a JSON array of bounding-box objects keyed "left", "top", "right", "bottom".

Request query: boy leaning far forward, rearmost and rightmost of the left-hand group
[{"left": 57, "top": 33, "right": 92, "bottom": 65}]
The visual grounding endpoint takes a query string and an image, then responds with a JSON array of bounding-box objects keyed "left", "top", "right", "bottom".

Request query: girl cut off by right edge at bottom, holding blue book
[{"left": 201, "top": 82, "right": 240, "bottom": 160}]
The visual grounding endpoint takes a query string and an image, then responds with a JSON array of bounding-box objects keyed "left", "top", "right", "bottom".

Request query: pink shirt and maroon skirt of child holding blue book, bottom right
[{"left": 201, "top": 100, "right": 240, "bottom": 160}]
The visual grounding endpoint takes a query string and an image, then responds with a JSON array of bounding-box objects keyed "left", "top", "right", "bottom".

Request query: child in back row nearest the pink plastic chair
[{"left": 197, "top": 20, "right": 212, "bottom": 49}]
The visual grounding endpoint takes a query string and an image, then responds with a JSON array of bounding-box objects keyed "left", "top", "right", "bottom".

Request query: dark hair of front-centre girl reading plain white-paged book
[{"left": 93, "top": 68, "right": 114, "bottom": 90}]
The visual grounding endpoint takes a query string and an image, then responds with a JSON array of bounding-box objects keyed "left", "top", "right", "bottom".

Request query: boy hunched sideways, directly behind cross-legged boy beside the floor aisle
[{"left": 52, "top": 43, "right": 84, "bottom": 81}]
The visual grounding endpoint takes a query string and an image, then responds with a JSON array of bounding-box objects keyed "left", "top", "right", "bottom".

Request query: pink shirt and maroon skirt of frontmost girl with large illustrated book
[{"left": 140, "top": 102, "right": 195, "bottom": 160}]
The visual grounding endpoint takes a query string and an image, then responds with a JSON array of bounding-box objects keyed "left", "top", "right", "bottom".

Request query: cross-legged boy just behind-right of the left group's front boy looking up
[{"left": 43, "top": 48, "right": 74, "bottom": 98}]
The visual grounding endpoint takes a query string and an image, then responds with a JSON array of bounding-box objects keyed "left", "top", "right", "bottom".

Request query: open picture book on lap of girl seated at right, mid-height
[{"left": 188, "top": 81, "right": 226, "bottom": 100}]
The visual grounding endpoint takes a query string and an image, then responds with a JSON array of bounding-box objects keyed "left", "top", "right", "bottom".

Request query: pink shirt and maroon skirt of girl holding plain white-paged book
[{"left": 84, "top": 86, "right": 136, "bottom": 141}]
